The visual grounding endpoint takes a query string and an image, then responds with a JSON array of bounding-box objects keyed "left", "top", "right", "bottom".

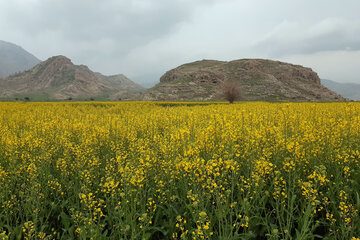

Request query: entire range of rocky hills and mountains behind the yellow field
[{"left": 0, "top": 40, "right": 354, "bottom": 101}]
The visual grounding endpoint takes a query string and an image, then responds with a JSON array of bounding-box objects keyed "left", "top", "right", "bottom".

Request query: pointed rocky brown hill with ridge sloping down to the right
[{"left": 0, "top": 56, "right": 143, "bottom": 100}]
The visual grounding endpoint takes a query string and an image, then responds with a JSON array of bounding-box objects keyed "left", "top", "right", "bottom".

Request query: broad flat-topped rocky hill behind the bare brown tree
[{"left": 141, "top": 59, "right": 345, "bottom": 101}]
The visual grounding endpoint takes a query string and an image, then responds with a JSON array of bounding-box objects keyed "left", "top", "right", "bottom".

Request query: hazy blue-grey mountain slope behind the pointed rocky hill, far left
[{"left": 0, "top": 40, "right": 40, "bottom": 77}]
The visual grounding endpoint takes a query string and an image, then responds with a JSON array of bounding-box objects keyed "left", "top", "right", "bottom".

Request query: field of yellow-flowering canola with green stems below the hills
[{"left": 0, "top": 102, "right": 360, "bottom": 240}]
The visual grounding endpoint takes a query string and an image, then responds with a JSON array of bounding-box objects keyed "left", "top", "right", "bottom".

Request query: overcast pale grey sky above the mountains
[{"left": 0, "top": 0, "right": 360, "bottom": 86}]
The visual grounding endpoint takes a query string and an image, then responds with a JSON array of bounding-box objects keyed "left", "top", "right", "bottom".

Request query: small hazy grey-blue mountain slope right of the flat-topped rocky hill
[{"left": 321, "top": 79, "right": 360, "bottom": 101}]
